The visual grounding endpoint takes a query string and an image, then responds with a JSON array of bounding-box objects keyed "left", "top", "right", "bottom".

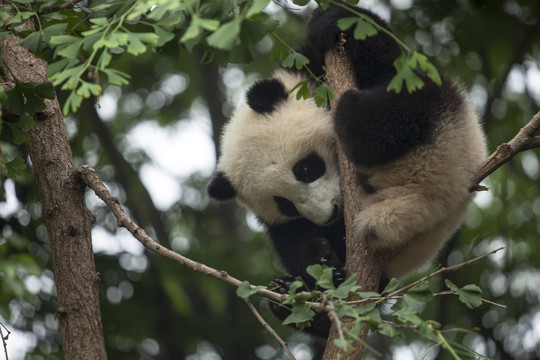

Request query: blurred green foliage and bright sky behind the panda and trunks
[{"left": 0, "top": 0, "right": 540, "bottom": 360}]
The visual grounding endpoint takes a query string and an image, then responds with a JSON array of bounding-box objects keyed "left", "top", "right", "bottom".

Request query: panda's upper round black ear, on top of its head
[{"left": 246, "top": 78, "right": 289, "bottom": 114}]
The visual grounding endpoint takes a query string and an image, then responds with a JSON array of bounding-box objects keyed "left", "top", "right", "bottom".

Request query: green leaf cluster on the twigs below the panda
[{"left": 237, "top": 264, "right": 488, "bottom": 358}]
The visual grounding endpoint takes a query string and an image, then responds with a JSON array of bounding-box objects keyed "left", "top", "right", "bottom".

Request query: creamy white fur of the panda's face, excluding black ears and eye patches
[{"left": 217, "top": 70, "right": 341, "bottom": 225}]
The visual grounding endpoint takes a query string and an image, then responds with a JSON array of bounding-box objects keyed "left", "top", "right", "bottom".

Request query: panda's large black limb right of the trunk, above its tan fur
[{"left": 334, "top": 86, "right": 432, "bottom": 166}]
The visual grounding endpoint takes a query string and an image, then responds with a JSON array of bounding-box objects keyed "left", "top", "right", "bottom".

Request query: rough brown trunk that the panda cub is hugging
[{"left": 323, "top": 40, "right": 390, "bottom": 360}]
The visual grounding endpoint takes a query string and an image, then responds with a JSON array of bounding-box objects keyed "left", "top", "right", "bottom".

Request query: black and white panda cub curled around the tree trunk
[{"left": 208, "top": 6, "right": 486, "bottom": 284}]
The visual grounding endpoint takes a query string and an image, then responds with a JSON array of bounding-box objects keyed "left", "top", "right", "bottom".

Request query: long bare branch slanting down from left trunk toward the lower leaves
[{"left": 76, "top": 165, "right": 286, "bottom": 302}]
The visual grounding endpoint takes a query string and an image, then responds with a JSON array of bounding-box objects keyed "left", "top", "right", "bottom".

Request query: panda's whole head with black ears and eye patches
[{"left": 208, "top": 70, "right": 342, "bottom": 226}]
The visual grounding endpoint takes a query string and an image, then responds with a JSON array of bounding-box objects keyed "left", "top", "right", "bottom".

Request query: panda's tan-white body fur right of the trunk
[{"left": 355, "top": 94, "right": 486, "bottom": 278}]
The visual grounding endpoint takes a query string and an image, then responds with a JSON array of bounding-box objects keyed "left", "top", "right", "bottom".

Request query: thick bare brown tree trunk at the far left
[{"left": 0, "top": 22, "right": 107, "bottom": 359}]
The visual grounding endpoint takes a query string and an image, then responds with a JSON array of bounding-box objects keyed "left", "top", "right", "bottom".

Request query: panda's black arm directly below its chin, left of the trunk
[{"left": 267, "top": 219, "right": 345, "bottom": 287}]
